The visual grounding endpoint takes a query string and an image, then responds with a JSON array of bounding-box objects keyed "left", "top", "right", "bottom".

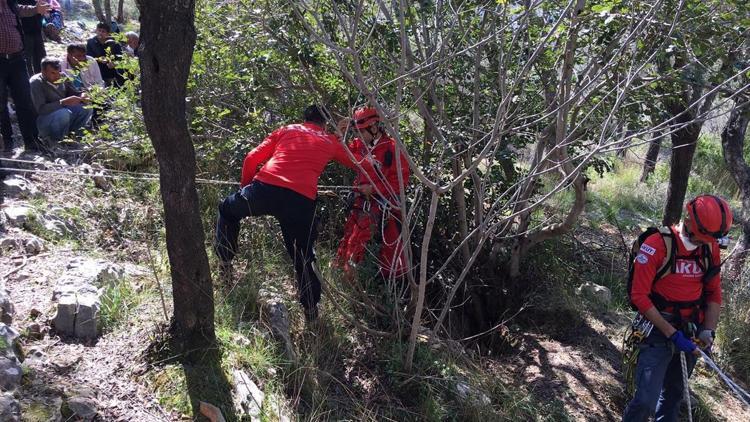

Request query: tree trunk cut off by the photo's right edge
[{"left": 721, "top": 106, "right": 750, "bottom": 275}]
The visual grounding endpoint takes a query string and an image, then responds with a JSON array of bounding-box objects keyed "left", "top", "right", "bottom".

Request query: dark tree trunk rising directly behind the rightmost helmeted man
[{"left": 662, "top": 109, "right": 702, "bottom": 226}]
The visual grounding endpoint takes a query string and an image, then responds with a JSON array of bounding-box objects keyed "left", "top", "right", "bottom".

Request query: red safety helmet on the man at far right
[{"left": 685, "top": 195, "right": 732, "bottom": 243}]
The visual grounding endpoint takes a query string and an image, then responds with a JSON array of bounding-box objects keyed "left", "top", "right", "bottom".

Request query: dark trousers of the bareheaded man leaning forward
[{"left": 215, "top": 181, "right": 320, "bottom": 309}]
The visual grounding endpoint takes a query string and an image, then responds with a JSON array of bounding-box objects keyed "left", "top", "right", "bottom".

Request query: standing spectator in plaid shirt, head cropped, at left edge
[{"left": 0, "top": 0, "right": 49, "bottom": 151}]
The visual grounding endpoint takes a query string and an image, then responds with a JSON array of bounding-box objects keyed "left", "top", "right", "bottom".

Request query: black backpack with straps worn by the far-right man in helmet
[{"left": 628, "top": 227, "right": 721, "bottom": 320}]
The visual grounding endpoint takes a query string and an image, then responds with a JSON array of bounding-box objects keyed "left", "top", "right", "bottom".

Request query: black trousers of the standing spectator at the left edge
[{"left": 0, "top": 54, "right": 39, "bottom": 149}]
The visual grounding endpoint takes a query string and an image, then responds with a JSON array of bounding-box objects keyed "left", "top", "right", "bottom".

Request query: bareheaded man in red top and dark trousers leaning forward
[{"left": 215, "top": 105, "right": 376, "bottom": 322}]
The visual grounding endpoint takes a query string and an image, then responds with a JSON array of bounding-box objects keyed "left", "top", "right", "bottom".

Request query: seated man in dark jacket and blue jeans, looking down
[{"left": 29, "top": 58, "right": 93, "bottom": 142}]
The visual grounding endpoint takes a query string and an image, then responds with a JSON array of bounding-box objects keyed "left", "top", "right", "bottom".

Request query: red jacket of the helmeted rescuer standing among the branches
[{"left": 349, "top": 135, "right": 410, "bottom": 202}]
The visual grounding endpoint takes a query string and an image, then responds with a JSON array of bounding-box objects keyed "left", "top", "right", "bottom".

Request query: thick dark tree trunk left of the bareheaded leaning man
[{"left": 139, "top": 0, "right": 215, "bottom": 358}]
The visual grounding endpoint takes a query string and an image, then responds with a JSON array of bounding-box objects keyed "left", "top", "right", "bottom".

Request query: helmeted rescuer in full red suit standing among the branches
[{"left": 335, "top": 107, "right": 409, "bottom": 278}]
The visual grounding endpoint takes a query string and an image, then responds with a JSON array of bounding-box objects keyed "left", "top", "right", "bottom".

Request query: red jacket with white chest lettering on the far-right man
[{"left": 630, "top": 227, "right": 721, "bottom": 317}]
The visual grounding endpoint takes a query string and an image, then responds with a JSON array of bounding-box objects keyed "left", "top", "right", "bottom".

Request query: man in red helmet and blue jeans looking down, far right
[{"left": 623, "top": 195, "right": 732, "bottom": 421}]
